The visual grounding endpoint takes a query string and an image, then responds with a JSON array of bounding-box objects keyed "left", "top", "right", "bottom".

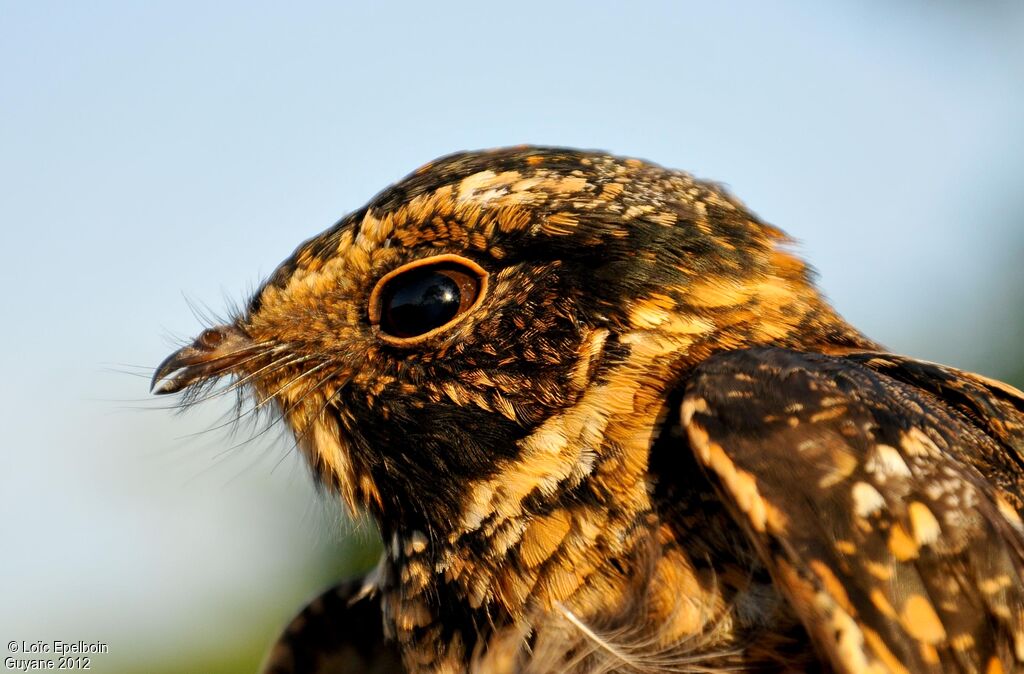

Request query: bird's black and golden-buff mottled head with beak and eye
[{"left": 154, "top": 148, "right": 860, "bottom": 534}]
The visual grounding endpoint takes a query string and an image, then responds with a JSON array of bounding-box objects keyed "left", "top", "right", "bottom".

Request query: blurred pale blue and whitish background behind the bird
[{"left": 0, "top": 0, "right": 1024, "bottom": 671}]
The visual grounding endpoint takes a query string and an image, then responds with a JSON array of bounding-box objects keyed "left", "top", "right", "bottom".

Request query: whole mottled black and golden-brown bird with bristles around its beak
[{"left": 153, "top": 145, "right": 1024, "bottom": 674}]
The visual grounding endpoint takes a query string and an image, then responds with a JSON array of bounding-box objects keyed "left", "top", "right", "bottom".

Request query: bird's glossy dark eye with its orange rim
[{"left": 368, "top": 254, "right": 487, "bottom": 346}]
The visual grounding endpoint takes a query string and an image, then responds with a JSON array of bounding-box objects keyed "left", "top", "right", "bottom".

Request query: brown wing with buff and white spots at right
[{"left": 682, "top": 348, "right": 1024, "bottom": 674}]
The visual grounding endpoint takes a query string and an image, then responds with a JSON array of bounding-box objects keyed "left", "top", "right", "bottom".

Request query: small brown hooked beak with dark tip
[{"left": 150, "top": 326, "right": 256, "bottom": 395}]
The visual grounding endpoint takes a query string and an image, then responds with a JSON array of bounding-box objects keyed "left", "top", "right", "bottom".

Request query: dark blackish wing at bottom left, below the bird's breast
[{"left": 260, "top": 580, "right": 404, "bottom": 674}]
